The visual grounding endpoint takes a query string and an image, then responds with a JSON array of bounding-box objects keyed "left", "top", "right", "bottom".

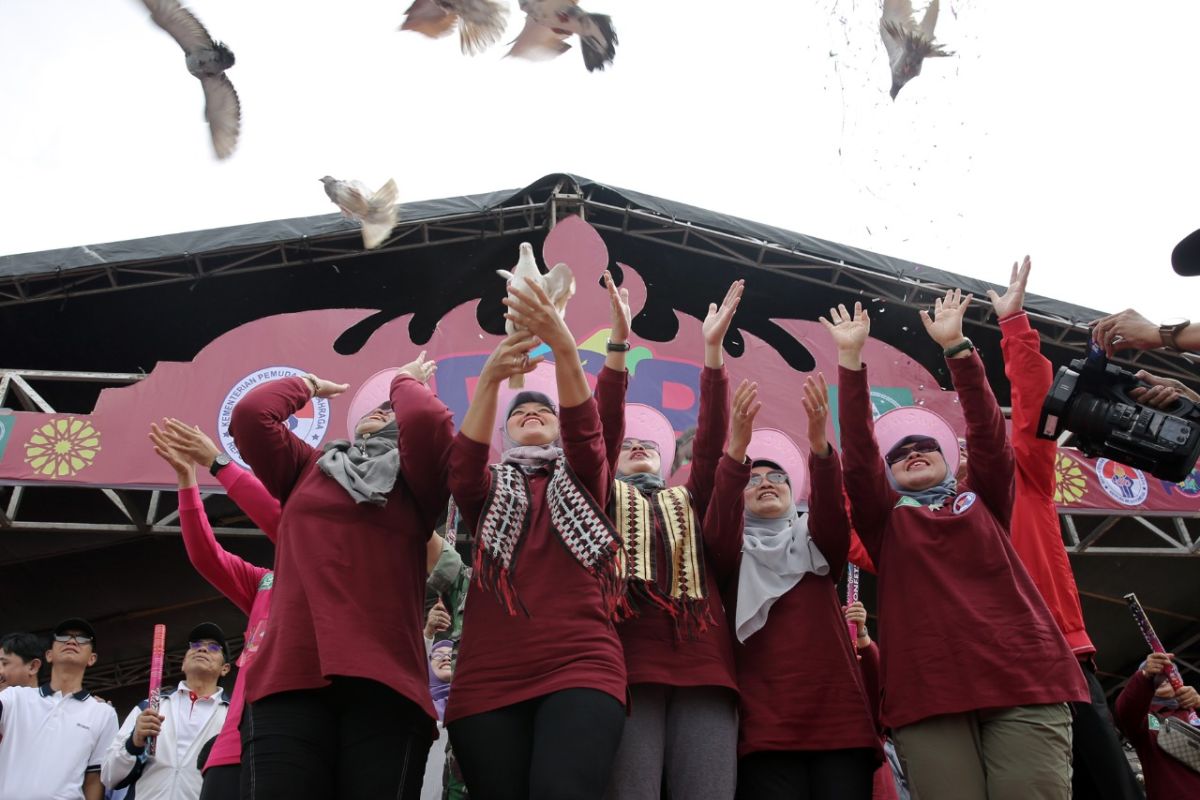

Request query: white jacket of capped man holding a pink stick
[{"left": 100, "top": 690, "right": 229, "bottom": 800}]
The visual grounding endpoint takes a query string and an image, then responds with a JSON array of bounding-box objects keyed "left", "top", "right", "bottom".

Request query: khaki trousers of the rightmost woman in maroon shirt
[{"left": 893, "top": 703, "right": 1070, "bottom": 800}]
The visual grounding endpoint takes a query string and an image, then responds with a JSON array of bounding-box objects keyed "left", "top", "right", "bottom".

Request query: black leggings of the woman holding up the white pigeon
[{"left": 448, "top": 688, "right": 625, "bottom": 800}]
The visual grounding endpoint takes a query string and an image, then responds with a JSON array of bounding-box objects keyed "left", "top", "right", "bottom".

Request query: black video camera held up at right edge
[{"left": 1038, "top": 342, "right": 1200, "bottom": 482}]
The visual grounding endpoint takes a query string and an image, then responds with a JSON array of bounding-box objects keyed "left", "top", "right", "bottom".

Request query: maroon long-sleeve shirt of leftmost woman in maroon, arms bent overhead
[{"left": 229, "top": 374, "right": 454, "bottom": 720}]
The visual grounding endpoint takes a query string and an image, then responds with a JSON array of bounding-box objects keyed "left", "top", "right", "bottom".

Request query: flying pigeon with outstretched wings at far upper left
[{"left": 143, "top": 0, "right": 241, "bottom": 158}]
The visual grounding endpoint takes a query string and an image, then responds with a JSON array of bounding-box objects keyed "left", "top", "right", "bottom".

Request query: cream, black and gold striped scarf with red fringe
[{"left": 612, "top": 475, "right": 715, "bottom": 639}]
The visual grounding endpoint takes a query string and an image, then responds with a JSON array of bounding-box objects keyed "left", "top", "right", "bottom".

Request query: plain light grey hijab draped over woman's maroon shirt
[{"left": 733, "top": 509, "right": 829, "bottom": 642}]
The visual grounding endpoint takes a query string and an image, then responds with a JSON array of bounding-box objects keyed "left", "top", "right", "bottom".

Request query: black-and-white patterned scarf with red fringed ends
[{"left": 474, "top": 458, "right": 623, "bottom": 616}]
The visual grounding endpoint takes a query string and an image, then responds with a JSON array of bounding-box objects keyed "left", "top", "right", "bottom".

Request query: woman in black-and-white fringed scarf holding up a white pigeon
[{"left": 445, "top": 277, "right": 625, "bottom": 800}]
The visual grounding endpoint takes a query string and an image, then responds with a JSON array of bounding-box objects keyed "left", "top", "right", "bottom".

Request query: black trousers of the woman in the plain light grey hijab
[{"left": 737, "top": 748, "right": 880, "bottom": 800}]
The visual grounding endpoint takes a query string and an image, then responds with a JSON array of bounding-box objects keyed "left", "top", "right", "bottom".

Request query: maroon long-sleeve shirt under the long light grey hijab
[{"left": 707, "top": 452, "right": 882, "bottom": 758}]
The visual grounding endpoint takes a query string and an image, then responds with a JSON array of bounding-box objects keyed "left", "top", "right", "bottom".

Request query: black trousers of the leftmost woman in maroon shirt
[{"left": 241, "top": 678, "right": 433, "bottom": 800}]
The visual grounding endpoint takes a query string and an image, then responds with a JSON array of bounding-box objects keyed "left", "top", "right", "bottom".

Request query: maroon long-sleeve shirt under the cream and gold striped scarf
[{"left": 595, "top": 367, "right": 742, "bottom": 691}]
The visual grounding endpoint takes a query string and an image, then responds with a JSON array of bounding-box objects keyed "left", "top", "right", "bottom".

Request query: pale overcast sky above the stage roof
[{"left": 0, "top": 0, "right": 1200, "bottom": 318}]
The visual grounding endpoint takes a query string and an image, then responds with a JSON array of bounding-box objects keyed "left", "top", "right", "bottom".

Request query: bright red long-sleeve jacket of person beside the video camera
[{"left": 998, "top": 312, "right": 1096, "bottom": 657}]
